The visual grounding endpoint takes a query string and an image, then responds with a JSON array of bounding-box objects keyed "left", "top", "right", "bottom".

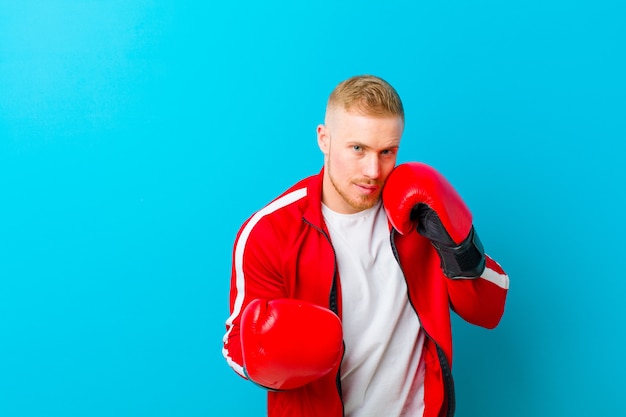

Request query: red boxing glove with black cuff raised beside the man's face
[{"left": 382, "top": 162, "right": 485, "bottom": 278}]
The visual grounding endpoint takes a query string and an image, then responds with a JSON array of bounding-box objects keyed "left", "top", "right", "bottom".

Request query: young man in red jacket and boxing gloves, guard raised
[{"left": 223, "top": 76, "right": 509, "bottom": 417}]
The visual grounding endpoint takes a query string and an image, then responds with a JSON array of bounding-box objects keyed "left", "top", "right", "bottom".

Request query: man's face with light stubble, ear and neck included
[{"left": 317, "top": 108, "right": 404, "bottom": 214}]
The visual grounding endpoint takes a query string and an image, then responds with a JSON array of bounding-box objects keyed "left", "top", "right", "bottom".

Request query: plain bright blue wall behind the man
[{"left": 0, "top": 0, "right": 626, "bottom": 417}]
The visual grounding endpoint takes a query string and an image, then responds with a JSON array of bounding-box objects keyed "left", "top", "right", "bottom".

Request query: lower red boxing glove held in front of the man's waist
[{"left": 240, "top": 298, "right": 343, "bottom": 390}]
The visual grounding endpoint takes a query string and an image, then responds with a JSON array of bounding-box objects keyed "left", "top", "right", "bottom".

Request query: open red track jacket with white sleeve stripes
[{"left": 223, "top": 171, "right": 509, "bottom": 417}]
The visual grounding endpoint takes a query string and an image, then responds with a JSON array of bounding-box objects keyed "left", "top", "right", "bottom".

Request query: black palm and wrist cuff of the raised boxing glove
[{"left": 411, "top": 203, "right": 485, "bottom": 278}]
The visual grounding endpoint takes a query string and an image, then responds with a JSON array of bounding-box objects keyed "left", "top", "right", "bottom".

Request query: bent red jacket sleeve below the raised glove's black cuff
[{"left": 447, "top": 255, "right": 509, "bottom": 329}]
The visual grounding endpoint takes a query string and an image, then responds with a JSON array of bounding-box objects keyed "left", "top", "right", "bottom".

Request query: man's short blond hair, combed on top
[{"left": 327, "top": 75, "right": 404, "bottom": 121}]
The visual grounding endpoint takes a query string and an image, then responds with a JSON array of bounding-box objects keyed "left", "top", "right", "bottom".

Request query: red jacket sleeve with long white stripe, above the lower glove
[{"left": 222, "top": 216, "right": 285, "bottom": 379}]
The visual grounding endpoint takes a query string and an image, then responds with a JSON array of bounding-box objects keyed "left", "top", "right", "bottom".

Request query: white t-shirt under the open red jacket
[{"left": 322, "top": 202, "right": 425, "bottom": 417}]
